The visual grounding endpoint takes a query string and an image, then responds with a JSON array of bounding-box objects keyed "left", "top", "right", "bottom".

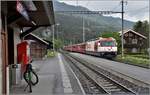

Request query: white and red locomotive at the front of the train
[{"left": 85, "top": 37, "right": 117, "bottom": 58}]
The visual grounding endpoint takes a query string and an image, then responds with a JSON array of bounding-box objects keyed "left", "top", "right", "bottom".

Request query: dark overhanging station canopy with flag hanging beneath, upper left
[{"left": 1, "top": 0, "right": 55, "bottom": 27}]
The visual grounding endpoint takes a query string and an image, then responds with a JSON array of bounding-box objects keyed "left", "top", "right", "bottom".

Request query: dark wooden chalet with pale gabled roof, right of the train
[{"left": 119, "top": 29, "right": 147, "bottom": 53}]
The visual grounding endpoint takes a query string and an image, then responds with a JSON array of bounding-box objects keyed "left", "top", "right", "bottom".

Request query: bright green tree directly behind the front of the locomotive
[{"left": 101, "top": 32, "right": 121, "bottom": 53}]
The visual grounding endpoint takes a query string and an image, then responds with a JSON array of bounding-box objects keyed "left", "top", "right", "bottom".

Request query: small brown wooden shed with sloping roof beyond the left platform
[{"left": 24, "top": 33, "right": 49, "bottom": 59}]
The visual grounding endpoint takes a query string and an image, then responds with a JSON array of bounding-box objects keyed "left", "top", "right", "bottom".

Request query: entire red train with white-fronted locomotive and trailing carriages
[{"left": 64, "top": 37, "right": 117, "bottom": 58}]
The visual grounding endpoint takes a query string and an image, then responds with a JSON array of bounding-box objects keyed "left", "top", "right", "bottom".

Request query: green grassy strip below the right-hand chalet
[{"left": 114, "top": 54, "right": 150, "bottom": 68}]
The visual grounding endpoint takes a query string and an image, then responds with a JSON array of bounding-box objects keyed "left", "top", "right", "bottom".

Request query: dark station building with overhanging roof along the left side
[{"left": 0, "top": 0, "right": 55, "bottom": 94}]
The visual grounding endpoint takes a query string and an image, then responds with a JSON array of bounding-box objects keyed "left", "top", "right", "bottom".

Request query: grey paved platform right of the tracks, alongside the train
[{"left": 70, "top": 53, "right": 150, "bottom": 85}]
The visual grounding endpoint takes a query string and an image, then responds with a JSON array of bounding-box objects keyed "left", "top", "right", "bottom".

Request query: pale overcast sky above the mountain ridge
[{"left": 58, "top": 0, "right": 150, "bottom": 21}]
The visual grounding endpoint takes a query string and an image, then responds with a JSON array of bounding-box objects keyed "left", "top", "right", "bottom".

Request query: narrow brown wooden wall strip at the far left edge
[{"left": 0, "top": 16, "right": 9, "bottom": 93}]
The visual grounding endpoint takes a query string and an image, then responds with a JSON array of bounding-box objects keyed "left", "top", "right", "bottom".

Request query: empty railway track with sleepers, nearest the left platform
[{"left": 65, "top": 54, "right": 136, "bottom": 95}]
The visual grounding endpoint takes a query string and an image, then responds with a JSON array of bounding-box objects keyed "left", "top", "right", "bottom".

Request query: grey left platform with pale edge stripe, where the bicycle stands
[{"left": 10, "top": 53, "right": 83, "bottom": 95}]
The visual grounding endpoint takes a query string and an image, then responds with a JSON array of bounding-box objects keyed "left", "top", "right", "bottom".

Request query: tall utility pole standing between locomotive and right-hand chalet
[{"left": 121, "top": 0, "right": 124, "bottom": 57}]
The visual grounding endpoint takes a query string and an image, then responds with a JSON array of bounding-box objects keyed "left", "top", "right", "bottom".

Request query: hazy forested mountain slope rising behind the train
[{"left": 54, "top": 1, "right": 134, "bottom": 43}]
